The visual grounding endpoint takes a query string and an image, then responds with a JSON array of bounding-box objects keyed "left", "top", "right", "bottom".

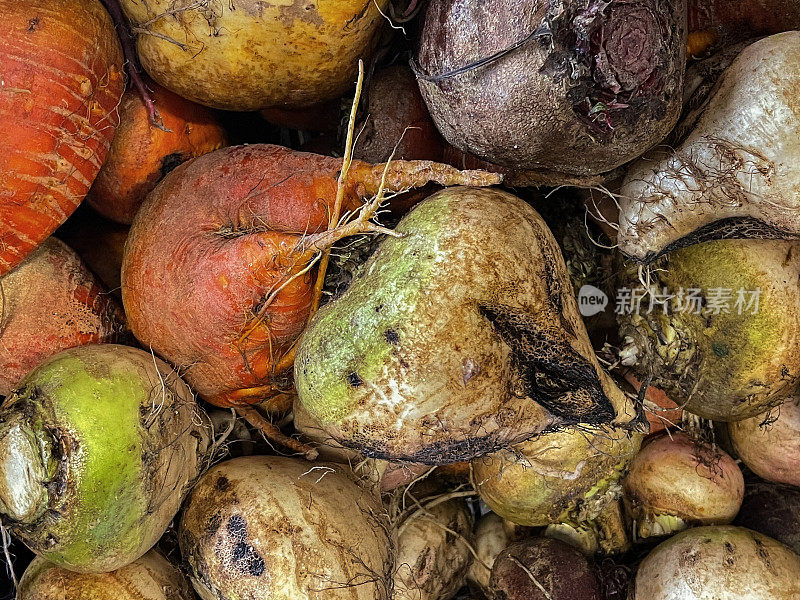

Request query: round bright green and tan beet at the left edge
[{"left": 0, "top": 344, "right": 211, "bottom": 573}]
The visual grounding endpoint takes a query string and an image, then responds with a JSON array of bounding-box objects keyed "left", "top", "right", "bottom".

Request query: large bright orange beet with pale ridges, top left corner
[{"left": 0, "top": 0, "right": 124, "bottom": 276}]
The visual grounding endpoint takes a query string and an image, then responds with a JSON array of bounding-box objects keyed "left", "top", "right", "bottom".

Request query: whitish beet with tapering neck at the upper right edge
[{"left": 618, "top": 31, "right": 800, "bottom": 262}]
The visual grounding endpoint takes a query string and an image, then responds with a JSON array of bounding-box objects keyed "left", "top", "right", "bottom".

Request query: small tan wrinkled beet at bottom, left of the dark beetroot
[{"left": 392, "top": 499, "right": 472, "bottom": 600}]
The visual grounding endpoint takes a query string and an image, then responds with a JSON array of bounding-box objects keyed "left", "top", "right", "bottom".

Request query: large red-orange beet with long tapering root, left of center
[{"left": 122, "top": 145, "right": 500, "bottom": 406}]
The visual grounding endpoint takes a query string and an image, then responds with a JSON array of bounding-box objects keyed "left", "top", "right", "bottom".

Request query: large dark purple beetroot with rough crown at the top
[{"left": 416, "top": 0, "right": 686, "bottom": 175}]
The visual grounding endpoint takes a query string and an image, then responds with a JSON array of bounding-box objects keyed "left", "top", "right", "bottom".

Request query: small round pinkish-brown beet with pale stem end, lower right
[{"left": 622, "top": 432, "right": 744, "bottom": 538}]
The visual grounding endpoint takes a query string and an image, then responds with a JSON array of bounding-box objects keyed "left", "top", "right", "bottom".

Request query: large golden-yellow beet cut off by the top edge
[{"left": 120, "top": 0, "right": 389, "bottom": 110}]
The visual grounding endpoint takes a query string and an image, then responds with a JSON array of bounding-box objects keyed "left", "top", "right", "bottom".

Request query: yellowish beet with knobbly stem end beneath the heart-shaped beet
[{"left": 472, "top": 426, "right": 642, "bottom": 553}]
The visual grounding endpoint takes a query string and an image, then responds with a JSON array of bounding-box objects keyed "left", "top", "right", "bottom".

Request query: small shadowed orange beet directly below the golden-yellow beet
[{"left": 86, "top": 84, "right": 226, "bottom": 224}]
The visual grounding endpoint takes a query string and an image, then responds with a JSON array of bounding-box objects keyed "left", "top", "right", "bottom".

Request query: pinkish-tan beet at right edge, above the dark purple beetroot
[{"left": 728, "top": 396, "right": 800, "bottom": 487}]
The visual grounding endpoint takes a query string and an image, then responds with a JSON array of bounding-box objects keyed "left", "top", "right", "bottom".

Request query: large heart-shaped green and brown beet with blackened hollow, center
[{"left": 295, "top": 187, "right": 635, "bottom": 464}]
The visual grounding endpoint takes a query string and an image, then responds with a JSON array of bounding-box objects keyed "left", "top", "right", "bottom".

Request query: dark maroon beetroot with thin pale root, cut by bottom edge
[{"left": 489, "top": 538, "right": 602, "bottom": 600}]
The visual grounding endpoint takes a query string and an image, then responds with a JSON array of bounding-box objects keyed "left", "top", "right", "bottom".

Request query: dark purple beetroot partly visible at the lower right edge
[{"left": 733, "top": 482, "right": 800, "bottom": 554}]
